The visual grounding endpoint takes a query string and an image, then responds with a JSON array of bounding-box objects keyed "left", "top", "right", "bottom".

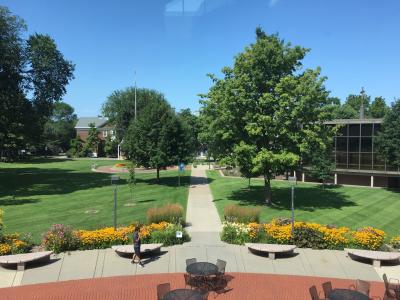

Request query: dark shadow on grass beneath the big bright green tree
[{"left": 223, "top": 186, "right": 358, "bottom": 211}]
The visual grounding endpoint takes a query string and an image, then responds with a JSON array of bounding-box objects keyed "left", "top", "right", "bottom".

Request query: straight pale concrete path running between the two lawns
[{"left": 186, "top": 165, "right": 222, "bottom": 246}]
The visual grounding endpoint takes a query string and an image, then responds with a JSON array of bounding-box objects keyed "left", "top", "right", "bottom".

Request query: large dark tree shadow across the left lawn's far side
[{"left": 0, "top": 168, "right": 126, "bottom": 199}]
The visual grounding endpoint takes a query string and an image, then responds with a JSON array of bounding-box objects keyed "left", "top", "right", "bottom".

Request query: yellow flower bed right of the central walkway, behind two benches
[{"left": 221, "top": 219, "right": 390, "bottom": 250}]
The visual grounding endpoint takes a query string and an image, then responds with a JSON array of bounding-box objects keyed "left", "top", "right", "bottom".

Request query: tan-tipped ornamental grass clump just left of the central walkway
[{"left": 147, "top": 203, "right": 184, "bottom": 224}]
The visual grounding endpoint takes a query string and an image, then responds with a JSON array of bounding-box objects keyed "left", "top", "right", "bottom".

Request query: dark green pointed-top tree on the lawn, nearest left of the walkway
[{"left": 122, "top": 93, "right": 190, "bottom": 179}]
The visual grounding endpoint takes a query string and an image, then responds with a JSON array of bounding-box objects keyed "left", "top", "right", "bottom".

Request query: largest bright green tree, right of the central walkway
[{"left": 201, "top": 28, "right": 330, "bottom": 204}]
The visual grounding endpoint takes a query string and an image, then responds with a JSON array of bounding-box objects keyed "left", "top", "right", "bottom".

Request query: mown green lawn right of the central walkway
[{"left": 208, "top": 171, "right": 400, "bottom": 236}]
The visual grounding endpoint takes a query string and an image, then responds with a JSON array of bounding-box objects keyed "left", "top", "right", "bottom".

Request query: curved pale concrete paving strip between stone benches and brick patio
[{"left": 0, "top": 243, "right": 400, "bottom": 287}]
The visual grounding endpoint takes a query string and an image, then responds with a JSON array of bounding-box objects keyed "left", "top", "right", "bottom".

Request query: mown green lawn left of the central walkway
[{"left": 0, "top": 159, "right": 190, "bottom": 242}]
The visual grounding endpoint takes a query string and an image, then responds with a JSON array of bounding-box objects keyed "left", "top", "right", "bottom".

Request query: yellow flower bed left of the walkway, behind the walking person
[{"left": 42, "top": 222, "right": 190, "bottom": 253}]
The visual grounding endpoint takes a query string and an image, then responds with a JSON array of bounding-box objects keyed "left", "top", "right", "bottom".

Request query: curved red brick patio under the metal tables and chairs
[{"left": 0, "top": 273, "right": 384, "bottom": 300}]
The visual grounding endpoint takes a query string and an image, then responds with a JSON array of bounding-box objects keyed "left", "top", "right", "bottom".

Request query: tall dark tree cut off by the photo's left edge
[{"left": 0, "top": 6, "right": 74, "bottom": 157}]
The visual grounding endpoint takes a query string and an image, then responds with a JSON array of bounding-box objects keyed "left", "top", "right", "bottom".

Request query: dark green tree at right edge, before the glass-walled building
[{"left": 375, "top": 99, "right": 400, "bottom": 168}]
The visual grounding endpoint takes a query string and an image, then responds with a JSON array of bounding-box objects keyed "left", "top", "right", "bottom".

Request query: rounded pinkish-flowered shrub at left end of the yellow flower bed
[{"left": 42, "top": 224, "right": 79, "bottom": 253}]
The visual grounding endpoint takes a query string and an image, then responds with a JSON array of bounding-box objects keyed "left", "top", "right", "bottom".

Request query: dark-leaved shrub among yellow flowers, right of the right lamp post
[{"left": 292, "top": 226, "right": 328, "bottom": 249}]
